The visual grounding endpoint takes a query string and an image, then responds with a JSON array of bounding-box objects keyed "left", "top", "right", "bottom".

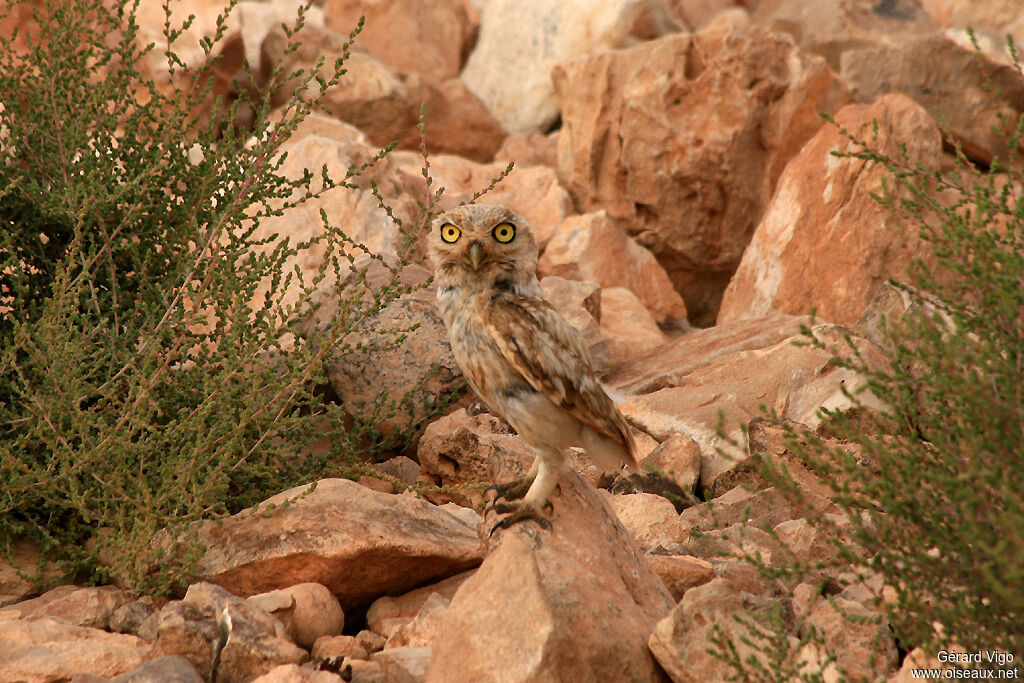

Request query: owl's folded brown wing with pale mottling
[{"left": 484, "top": 296, "right": 636, "bottom": 465}]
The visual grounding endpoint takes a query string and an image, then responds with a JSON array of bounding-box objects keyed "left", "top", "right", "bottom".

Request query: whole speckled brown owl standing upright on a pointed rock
[{"left": 428, "top": 205, "right": 636, "bottom": 526}]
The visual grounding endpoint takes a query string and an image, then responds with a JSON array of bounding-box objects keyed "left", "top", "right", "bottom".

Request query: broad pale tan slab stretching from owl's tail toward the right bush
[{"left": 620, "top": 321, "right": 885, "bottom": 489}]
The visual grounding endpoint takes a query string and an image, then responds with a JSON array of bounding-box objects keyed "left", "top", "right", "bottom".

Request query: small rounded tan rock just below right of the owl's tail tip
[{"left": 611, "top": 434, "right": 700, "bottom": 512}]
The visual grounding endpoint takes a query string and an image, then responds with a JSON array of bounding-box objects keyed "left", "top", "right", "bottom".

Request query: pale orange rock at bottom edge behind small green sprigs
[{"left": 649, "top": 579, "right": 782, "bottom": 683}]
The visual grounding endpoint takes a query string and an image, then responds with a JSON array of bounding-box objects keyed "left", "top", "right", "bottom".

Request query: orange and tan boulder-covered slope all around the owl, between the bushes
[{"left": 0, "top": 0, "right": 1024, "bottom": 683}]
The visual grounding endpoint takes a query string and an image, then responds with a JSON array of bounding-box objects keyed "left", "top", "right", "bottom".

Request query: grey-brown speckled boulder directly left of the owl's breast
[{"left": 321, "top": 265, "right": 462, "bottom": 447}]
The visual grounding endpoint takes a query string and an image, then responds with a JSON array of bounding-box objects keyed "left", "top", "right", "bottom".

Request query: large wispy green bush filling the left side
[{"left": 0, "top": 0, "right": 439, "bottom": 590}]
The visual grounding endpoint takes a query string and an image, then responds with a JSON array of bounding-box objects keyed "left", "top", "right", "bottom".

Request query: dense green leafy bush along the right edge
[{"left": 719, "top": 44, "right": 1024, "bottom": 680}]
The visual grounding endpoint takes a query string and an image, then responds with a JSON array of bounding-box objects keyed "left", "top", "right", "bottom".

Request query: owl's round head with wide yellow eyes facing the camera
[{"left": 428, "top": 204, "right": 537, "bottom": 285}]
